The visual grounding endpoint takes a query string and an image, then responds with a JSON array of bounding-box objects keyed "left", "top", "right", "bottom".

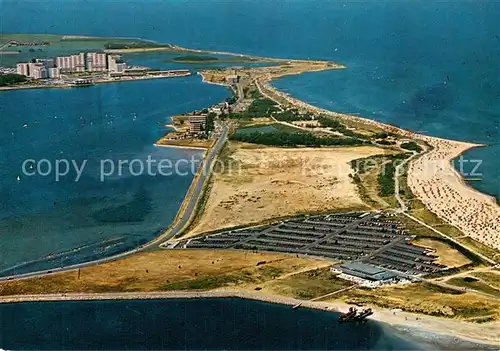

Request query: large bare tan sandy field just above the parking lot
[{"left": 186, "top": 143, "right": 387, "bottom": 237}]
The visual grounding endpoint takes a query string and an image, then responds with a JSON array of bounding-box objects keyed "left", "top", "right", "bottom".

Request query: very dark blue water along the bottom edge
[{"left": 0, "top": 299, "right": 424, "bottom": 350}]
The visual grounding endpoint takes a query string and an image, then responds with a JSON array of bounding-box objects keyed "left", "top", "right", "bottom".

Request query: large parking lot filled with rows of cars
[{"left": 176, "top": 212, "right": 443, "bottom": 275}]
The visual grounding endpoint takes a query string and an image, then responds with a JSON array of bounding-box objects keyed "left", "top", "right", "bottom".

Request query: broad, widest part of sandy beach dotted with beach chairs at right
[{"left": 408, "top": 137, "right": 500, "bottom": 250}]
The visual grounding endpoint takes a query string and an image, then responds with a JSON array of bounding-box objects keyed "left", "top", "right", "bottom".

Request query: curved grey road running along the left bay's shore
[{"left": 0, "top": 126, "right": 229, "bottom": 282}]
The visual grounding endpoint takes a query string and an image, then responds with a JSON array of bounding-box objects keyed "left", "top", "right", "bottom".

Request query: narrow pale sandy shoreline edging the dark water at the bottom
[{"left": 0, "top": 290, "right": 500, "bottom": 346}]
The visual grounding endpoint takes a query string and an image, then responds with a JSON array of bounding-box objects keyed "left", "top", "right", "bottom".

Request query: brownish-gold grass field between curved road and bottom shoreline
[{"left": 0, "top": 250, "right": 327, "bottom": 296}]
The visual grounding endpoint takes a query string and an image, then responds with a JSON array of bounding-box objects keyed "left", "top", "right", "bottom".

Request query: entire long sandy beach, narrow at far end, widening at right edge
[{"left": 257, "top": 77, "right": 500, "bottom": 250}]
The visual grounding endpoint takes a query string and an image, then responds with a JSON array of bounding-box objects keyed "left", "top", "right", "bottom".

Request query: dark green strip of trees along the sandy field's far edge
[{"left": 231, "top": 131, "right": 367, "bottom": 147}]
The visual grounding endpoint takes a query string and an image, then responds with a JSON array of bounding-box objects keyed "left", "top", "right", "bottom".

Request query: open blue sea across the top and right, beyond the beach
[{"left": 0, "top": 0, "right": 500, "bottom": 197}]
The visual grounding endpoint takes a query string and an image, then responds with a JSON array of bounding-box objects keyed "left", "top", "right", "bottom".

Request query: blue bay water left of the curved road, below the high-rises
[{"left": 0, "top": 76, "right": 230, "bottom": 275}]
